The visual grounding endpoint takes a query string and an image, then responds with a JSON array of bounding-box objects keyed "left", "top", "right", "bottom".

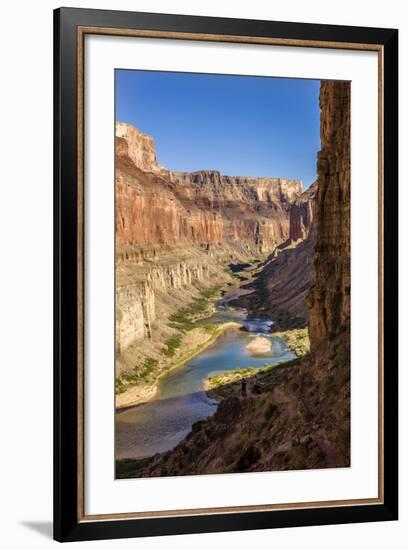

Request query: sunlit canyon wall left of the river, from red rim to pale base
[{"left": 115, "top": 123, "right": 302, "bottom": 401}]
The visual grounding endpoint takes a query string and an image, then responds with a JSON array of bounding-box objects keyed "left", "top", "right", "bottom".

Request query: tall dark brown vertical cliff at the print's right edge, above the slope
[{"left": 308, "top": 81, "right": 350, "bottom": 349}]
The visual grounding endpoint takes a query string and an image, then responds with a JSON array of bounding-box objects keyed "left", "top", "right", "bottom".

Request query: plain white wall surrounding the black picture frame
[{"left": 0, "top": 0, "right": 408, "bottom": 550}]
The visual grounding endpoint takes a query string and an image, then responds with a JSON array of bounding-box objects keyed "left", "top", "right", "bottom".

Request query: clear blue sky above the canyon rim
[{"left": 116, "top": 69, "right": 320, "bottom": 188}]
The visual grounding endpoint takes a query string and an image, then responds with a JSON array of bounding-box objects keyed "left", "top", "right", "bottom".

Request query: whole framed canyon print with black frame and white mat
[{"left": 54, "top": 8, "right": 398, "bottom": 541}]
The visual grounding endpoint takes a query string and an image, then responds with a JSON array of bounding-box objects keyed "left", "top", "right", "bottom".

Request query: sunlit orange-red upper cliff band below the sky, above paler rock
[{"left": 116, "top": 123, "right": 302, "bottom": 257}]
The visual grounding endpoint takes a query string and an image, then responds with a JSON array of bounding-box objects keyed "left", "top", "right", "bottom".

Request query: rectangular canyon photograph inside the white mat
[{"left": 112, "top": 68, "right": 353, "bottom": 479}]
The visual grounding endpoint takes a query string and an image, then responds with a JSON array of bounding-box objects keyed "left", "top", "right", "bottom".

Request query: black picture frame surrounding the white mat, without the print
[{"left": 54, "top": 8, "right": 398, "bottom": 542}]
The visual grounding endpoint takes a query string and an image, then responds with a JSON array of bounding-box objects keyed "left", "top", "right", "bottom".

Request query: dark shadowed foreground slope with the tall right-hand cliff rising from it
[{"left": 117, "top": 81, "right": 350, "bottom": 477}]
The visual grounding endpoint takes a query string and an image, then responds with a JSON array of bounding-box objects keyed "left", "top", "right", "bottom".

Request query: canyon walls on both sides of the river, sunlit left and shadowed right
[{"left": 116, "top": 81, "right": 350, "bottom": 477}]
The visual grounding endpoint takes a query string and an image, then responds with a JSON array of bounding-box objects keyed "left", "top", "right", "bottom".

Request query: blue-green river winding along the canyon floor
[{"left": 115, "top": 297, "right": 295, "bottom": 459}]
